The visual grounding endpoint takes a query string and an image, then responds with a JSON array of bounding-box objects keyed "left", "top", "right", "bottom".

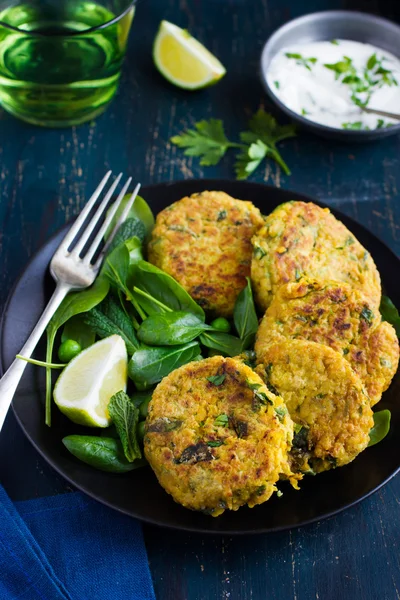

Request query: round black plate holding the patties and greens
[{"left": 0, "top": 180, "right": 400, "bottom": 534}]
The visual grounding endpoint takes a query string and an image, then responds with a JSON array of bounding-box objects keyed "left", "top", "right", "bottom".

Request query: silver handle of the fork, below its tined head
[{"left": 0, "top": 283, "right": 72, "bottom": 431}]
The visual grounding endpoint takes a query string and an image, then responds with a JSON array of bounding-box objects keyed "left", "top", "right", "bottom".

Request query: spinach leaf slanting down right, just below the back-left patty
[{"left": 132, "top": 260, "right": 205, "bottom": 321}]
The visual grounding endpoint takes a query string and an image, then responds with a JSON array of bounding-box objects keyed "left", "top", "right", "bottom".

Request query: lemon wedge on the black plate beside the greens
[{"left": 54, "top": 335, "right": 128, "bottom": 427}]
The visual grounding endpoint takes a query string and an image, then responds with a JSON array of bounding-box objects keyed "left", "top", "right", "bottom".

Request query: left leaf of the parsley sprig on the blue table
[{"left": 171, "top": 119, "right": 237, "bottom": 167}]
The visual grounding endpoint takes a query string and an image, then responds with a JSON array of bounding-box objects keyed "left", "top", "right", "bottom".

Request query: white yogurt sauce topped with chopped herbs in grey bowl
[{"left": 267, "top": 40, "right": 400, "bottom": 130}]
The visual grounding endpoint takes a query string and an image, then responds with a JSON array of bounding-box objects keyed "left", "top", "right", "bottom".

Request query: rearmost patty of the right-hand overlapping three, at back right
[{"left": 251, "top": 202, "right": 381, "bottom": 310}]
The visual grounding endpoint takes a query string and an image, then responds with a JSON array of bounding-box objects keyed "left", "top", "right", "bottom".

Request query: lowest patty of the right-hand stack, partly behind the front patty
[{"left": 256, "top": 339, "right": 373, "bottom": 472}]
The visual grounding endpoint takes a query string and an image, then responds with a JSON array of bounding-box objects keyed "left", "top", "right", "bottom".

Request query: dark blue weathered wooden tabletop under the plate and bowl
[{"left": 0, "top": 0, "right": 400, "bottom": 600}]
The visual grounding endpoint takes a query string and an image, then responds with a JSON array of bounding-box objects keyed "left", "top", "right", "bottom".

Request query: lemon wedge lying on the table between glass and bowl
[{"left": 153, "top": 21, "right": 226, "bottom": 90}]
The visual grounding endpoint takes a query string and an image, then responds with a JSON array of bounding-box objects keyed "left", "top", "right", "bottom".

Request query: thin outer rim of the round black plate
[{"left": 0, "top": 178, "right": 400, "bottom": 536}]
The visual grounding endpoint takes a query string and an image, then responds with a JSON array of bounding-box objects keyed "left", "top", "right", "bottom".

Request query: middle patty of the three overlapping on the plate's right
[{"left": 255, "top": 279, "right": 399, "bottom": 406}]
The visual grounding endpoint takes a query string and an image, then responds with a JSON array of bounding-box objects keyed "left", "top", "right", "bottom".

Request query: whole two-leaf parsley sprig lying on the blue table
[{"left": 171, "top": 108, "right": 296, "bottom": 179}]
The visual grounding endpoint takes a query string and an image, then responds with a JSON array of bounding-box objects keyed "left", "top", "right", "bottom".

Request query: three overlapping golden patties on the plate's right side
[{"left": 251, "top": 202, "right": 399, "bottom": 473}]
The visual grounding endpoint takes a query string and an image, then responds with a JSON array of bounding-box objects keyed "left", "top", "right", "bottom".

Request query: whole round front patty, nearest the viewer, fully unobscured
[{"left": 144, "top": 356, "right": 297, "bottom": 516}]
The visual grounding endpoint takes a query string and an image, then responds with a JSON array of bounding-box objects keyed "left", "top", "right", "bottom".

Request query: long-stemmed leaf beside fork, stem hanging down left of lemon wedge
[{"left": 45, "top": 276, "right": 110, "bottom": 427}]
